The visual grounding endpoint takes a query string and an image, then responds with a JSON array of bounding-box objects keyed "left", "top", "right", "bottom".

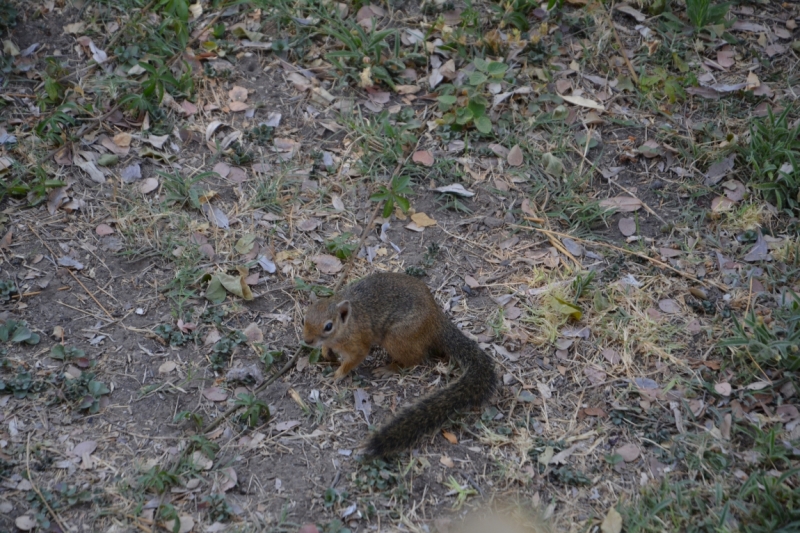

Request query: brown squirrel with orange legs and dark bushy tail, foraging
[{"left": 303, "top": 273, "right": 497, "bottom": 457}]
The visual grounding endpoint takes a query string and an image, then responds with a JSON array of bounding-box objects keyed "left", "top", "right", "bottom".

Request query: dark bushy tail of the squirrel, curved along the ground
[{"left": 365, "top": 322, "right": 496, "bottom": 457}]
